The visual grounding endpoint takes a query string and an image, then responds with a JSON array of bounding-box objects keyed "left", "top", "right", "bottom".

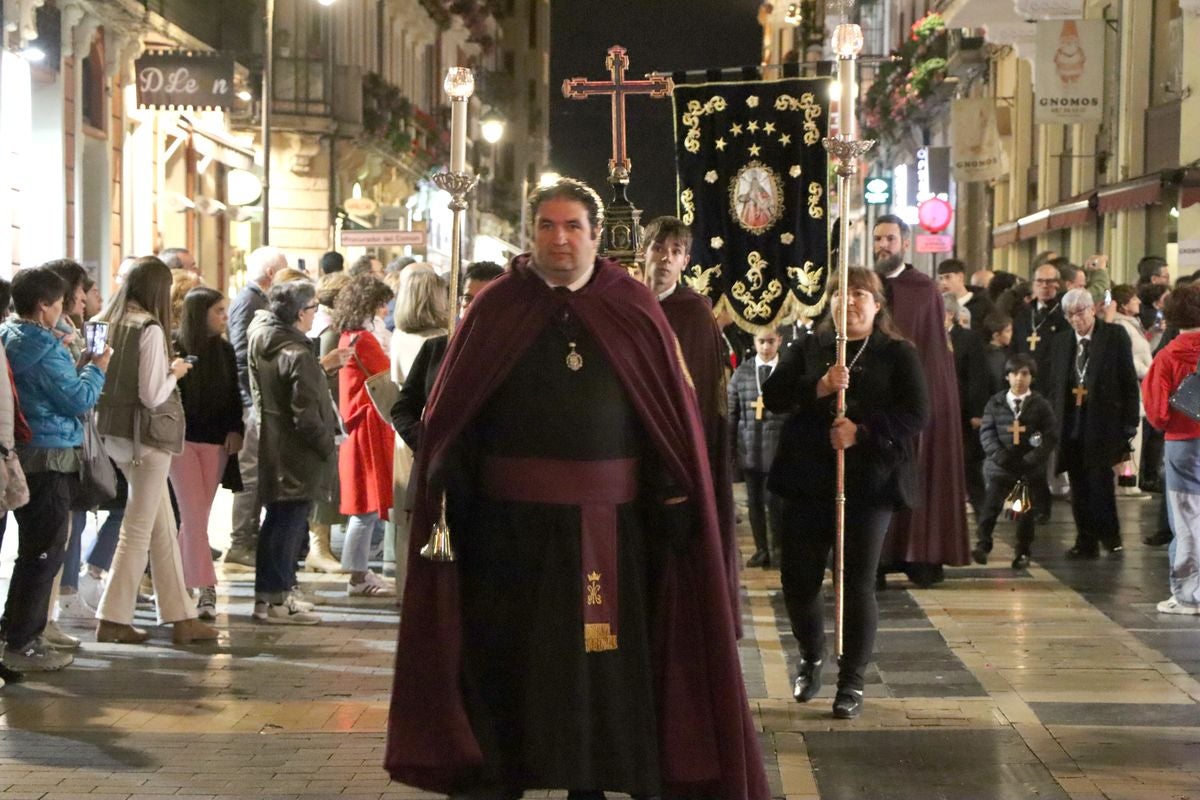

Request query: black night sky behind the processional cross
[{"left": 550, "top": 0, "right": 762, "bottom": 222}]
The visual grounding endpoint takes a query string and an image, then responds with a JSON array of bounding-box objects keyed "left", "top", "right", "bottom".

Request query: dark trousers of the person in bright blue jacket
[{"left": 0, "top": 473, "right": 79, "bottom": 650}]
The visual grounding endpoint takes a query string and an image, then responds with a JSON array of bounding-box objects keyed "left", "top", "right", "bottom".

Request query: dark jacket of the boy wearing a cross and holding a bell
[{"left": 979, "top": 389, "right": 1058, "bottom": 477}]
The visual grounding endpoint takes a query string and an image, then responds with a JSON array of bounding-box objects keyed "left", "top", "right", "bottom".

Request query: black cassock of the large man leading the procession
[{"left": 452, "top": 309, "right": 661, "bottom": 794}]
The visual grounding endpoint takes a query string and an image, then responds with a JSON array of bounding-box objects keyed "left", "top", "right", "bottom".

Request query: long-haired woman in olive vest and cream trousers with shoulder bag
[{"left": 96, "top": 255, "right": 217, "bottom": 644}]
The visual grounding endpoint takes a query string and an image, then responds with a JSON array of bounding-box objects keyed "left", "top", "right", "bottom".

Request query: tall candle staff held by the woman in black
[{"left": 822, "top": 23, "right": 875, "bottom": 658}]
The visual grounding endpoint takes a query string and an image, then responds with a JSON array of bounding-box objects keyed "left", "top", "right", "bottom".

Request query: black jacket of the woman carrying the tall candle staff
[{"left": 762, "top": 331, "right": 929, "bottom": 509}]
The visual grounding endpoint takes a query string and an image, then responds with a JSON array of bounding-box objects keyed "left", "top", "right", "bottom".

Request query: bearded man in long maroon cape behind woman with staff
[{"left": 874, "top": 213, "right": 970, "bottom": 587}]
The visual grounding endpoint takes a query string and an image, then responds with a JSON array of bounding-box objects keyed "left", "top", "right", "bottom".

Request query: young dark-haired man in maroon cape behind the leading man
[{"left": 644, "top": 217, "right": 742, "bottom": 638}]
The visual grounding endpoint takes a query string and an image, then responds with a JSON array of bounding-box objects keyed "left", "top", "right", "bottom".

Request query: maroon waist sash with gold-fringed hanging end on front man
[{"left": 481, "top": 456, "right": 637, "bottom": 652}]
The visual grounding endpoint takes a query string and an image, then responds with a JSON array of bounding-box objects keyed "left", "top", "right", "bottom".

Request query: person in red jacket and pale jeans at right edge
[{"left": 1141, "top": 283, "right": 1200, "bottom": 615}]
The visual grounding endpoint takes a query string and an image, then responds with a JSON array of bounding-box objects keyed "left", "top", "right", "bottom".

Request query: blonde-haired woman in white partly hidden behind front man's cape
[{"left": 383, "top": 261, "right": 450, "bottom": 578}]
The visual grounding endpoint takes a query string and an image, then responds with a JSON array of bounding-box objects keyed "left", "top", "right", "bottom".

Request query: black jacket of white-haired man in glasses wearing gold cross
[{"left": 1044, "top": 319, "right": 1141, "bottom": 465}]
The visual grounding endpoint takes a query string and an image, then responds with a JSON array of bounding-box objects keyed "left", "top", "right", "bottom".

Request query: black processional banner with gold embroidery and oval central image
[{"left": 672, "top": 78, "right": 832, "bottom": 332}]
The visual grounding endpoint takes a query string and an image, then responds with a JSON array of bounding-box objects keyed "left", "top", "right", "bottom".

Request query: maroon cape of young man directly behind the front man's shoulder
[{"left": 662, "top": 283, "right": 742, "bottom": 639}]
